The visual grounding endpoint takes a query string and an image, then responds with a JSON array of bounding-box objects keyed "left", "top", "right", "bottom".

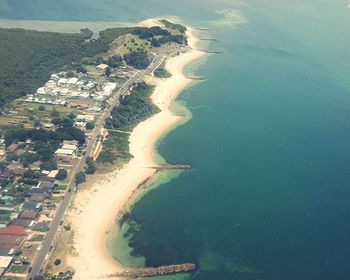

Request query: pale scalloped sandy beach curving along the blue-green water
[{"left": 67, "top": 19, "right": 205, "bottom": 280}]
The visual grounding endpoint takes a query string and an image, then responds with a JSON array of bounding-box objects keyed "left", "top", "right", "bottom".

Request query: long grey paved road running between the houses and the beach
[{"left": 28, "top": 56, "right": 165, "bottom": 279}]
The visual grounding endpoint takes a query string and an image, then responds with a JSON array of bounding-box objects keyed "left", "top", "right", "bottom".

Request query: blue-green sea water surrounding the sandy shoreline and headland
[{"left": 0, "top": 0, "right": 350, "bottom": 280}]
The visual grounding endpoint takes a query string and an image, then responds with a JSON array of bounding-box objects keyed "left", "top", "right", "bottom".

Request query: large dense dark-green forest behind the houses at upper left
[{"left": 0, "top": 28, "right": 136, "bottom": 107}]
